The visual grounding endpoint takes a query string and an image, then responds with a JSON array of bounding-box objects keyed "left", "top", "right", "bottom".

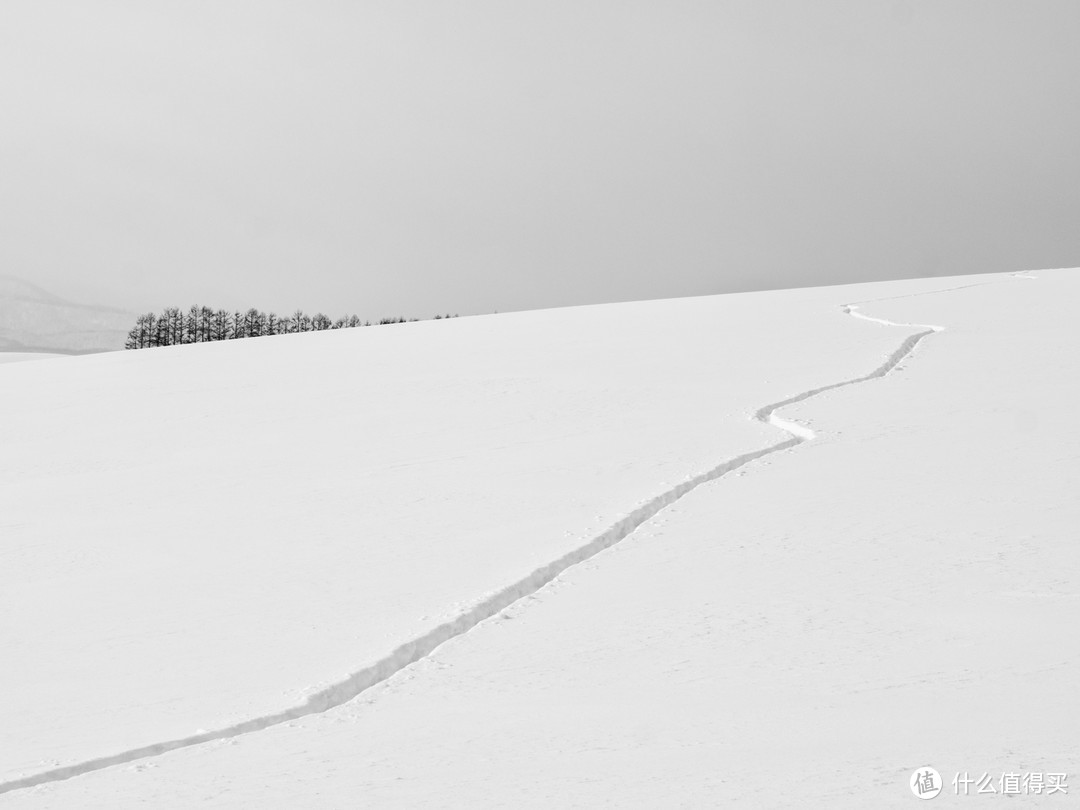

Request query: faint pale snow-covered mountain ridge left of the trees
[{"left": 0, "top": 275, "right": 136, "bottom": 354}]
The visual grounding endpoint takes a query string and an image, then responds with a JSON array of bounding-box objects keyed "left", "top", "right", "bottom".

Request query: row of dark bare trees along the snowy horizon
[{"left": 124, "top": 306, "right": 457, "bottom": 349}]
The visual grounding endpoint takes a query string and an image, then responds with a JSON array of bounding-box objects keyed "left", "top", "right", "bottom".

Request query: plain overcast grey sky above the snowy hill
[{"left": 0, "top": 0, "right": 1080, "bottom": 318}]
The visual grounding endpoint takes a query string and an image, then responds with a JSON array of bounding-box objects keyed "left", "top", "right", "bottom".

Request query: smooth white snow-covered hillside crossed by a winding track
[{"left": 0, "top": 271, "right": 1080, "bottom": 807}]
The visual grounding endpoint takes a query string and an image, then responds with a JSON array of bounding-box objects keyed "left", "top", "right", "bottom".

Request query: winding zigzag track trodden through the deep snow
[{"left": 0, "top": 282, "right": 1010, "bottom": 794}]
